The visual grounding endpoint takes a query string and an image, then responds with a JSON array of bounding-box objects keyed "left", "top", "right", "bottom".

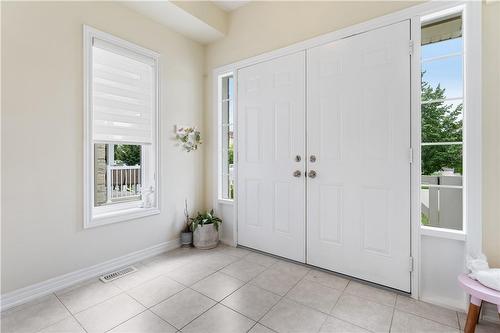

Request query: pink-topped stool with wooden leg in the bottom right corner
[{"left": 458, "top": 274, "right": 500, "bottom": 333}]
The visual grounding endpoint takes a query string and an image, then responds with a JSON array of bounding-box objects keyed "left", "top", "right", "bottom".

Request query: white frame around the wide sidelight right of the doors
[{"left": 418, "top": 2, "right": 482, "bottom": 246}]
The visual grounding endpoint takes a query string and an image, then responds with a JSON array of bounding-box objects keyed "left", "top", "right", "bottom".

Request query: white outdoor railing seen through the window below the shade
[{"left": 107, "top": 165, "right": 141, "bottom": 203}]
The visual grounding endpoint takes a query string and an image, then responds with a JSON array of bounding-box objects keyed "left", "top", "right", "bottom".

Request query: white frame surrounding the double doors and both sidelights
[{"left": 212, "top": 1, "right": 482, "bottom": 299}]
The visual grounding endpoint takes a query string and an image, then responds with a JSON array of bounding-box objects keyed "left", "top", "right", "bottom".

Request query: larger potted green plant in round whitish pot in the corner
[{"left": 191, "top": 209, "right": 222, "bottom": 250}]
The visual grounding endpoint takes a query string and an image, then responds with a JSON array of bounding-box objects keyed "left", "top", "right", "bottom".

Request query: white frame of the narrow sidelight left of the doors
[{"left": 216, "top": 72, "right": 236, "bottom": 204}]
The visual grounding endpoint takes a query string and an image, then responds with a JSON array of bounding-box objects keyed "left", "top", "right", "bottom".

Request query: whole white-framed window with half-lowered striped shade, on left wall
[{"left": 84, "top": 26, "right": 159, "bottom": 227}]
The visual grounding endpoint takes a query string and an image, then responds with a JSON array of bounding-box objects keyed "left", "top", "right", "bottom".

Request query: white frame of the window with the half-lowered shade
[{"left": 83, "top": 25, "right": 160, "bottom": 228}]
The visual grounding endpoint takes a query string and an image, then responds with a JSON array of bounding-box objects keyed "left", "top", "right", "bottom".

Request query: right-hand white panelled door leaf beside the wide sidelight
[{"left": 307, "top": 21, "right": 410, "bottom": 291}]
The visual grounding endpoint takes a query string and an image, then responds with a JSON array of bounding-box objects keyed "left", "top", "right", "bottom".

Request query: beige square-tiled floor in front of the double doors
[{"left": 1, "top": 246, "right": 500, "bottom": 333}]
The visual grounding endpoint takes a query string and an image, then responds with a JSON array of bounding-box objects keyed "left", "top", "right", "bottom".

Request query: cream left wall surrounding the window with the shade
[{"left": 1, "top": 2, "right": 204, "bottom": 294}]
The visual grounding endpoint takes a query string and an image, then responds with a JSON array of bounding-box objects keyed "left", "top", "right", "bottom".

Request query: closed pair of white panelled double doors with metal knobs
[{"left": 237, "top": 21, "right": 410, "bottom": 291}]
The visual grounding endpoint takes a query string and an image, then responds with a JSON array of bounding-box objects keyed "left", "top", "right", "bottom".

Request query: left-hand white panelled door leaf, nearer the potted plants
[{"left": 237, "top": 52, "right": 305, "bottom": 262}]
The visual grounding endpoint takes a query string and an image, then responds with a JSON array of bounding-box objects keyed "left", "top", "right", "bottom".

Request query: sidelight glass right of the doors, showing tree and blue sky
[{"left": 421, "top": 13, "right": 466, "bottom": 230}]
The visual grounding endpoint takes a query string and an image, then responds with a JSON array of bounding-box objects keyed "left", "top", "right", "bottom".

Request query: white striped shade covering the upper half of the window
[{"left": 92, "top": 37, "right": 156, "bottom": 144}]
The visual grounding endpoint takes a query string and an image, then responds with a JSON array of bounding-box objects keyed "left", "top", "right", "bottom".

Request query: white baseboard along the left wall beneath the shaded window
[{"left": 0, "top": 239, "right": 180, "bottom": 311}]
